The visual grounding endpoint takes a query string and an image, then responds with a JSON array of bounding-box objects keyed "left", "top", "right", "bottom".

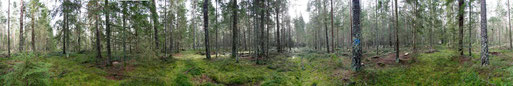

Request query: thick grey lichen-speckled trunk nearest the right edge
[{"left": 481, "top": 0, "right": 490, "bottom": 65}]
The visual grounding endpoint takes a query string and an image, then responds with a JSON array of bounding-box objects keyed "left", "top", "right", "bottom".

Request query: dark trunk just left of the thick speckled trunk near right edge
[{"left": 458, "top": 0, "right": 465, "bottom": 56}]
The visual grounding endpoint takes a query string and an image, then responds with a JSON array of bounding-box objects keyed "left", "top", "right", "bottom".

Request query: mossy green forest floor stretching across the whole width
[{"left": 0, "top": 48, "right": 513, "bottom": 86}]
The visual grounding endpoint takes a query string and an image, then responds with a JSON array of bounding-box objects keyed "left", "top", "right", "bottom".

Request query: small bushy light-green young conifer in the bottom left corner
[{"left": 1, "top": 54, "right": 51, "bottom": 86}]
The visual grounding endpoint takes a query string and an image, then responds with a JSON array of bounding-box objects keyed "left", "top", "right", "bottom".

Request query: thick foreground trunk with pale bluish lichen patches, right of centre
[{"left": 351, "top": 0, "right": 362, "bottom": 71}]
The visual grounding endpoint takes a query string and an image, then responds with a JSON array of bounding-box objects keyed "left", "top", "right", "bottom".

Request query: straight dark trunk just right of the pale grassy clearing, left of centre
[{"left": 203, "top": 0, "right": 210, "bottom": 59}]
